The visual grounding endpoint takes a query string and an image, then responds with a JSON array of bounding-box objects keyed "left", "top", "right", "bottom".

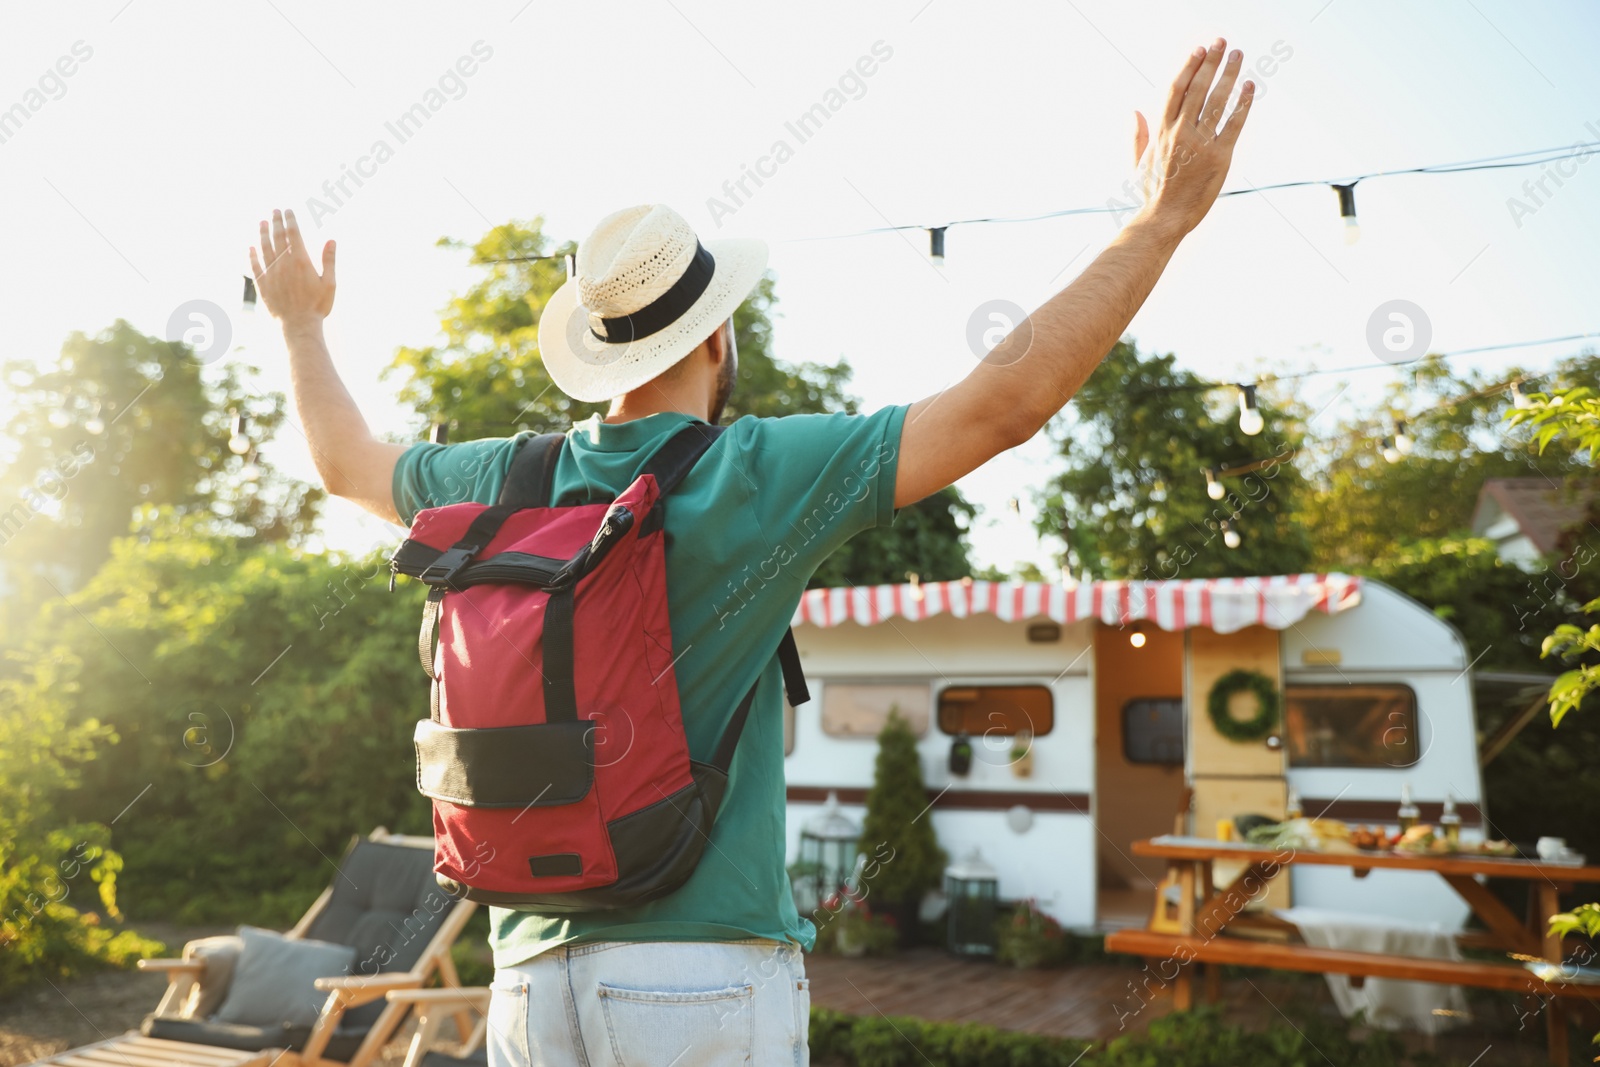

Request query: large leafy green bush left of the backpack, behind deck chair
[{"left": 6, "top": 518, "right": 429, "bottom": 921}]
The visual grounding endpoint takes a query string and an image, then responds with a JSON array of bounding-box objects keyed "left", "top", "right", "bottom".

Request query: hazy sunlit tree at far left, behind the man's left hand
[{"left": 0, "top": 320, "right": 322, "bottom": 620}]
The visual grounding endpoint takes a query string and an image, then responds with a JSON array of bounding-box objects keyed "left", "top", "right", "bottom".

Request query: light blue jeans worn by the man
[{"left": 486, "top": 937, "right": 811, "bottom": 1067}]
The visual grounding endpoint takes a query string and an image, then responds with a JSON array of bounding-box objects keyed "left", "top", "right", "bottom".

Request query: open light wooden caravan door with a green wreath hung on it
[{"left": 1184, "top": 625, "right": 1286, "bottom": 907}]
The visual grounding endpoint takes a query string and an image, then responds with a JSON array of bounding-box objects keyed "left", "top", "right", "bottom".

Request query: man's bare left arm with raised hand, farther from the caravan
[{"left": 250, "top": 211, "right": 405, "bottom": 523}]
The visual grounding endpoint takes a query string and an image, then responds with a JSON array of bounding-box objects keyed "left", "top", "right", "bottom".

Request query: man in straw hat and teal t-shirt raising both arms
[{"left": 250, "top": 38, "right": 1254, "bottom": 1067}]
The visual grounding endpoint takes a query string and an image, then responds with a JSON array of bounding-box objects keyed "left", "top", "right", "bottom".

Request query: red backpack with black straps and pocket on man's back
[{"left": 390, "top": 422, "right": 810, "bottom": 912}]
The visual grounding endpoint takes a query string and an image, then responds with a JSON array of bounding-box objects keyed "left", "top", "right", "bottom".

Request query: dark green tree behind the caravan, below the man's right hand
[{"left": 1037, "top": 341, "right": 1310, "bottom": 579}]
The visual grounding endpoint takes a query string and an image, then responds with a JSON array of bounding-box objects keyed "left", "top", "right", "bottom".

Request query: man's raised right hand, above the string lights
[{"left": 1133, "top": 37, "right": 1256, "bottom": 234}]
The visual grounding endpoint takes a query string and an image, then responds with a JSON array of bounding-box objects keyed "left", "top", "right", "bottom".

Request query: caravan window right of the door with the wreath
[{"left": 1283, "top": 683, "right": 1422, "bottom": 768}]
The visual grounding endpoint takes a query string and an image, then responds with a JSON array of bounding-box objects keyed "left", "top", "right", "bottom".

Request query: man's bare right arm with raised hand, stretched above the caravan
[{"left": 894, "top": 38, "right": 1254, "bottom": 507}]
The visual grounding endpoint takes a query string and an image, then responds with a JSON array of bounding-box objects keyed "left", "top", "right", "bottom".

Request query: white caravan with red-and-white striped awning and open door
[{"left": 786, "top": 574, "right": 1485, "bottom": 929}]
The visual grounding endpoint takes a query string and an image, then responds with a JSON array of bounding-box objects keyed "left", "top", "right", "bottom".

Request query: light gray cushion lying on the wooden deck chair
[{"left": 214, "top": 926, "right": 355, "bottom": 1027}]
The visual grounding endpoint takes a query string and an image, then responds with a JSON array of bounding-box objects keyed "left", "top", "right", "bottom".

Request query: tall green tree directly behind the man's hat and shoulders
[{"left": 389, "top": 219, "right": 976, "bottom": 585}]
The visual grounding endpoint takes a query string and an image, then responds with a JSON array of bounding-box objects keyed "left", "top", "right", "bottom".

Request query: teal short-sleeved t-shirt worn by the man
[{"left": 394, "top": 406, "right": 906, "bottom": 966}]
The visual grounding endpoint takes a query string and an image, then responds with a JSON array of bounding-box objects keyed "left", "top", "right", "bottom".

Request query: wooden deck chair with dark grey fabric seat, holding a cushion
[{"left": 35, "top": 827, "right": 477, "bottom": 1067}]
